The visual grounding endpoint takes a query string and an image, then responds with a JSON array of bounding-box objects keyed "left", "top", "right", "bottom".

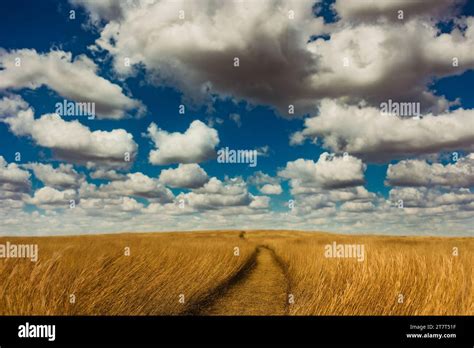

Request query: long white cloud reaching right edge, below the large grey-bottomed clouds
[{"left": 293, "top": 100, "right": 474, "bottom": 161}]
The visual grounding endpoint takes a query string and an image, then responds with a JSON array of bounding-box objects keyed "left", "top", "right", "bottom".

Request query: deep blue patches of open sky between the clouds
[{"left": 0, "top": 0, "right": 474, "bottom": 209}]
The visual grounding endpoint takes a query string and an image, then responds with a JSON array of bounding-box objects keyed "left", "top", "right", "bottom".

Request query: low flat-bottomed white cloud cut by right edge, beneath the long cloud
[{"left": 387, "top": 153, "right": 474, "bottom": 187}]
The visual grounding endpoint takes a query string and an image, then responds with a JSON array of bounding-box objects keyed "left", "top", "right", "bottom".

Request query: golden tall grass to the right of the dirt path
[{"left": 250, "top": 233, "right": 474, "bottom": 315}]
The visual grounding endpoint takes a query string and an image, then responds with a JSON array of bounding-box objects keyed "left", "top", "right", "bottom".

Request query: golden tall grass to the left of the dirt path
[{"left": 0, "top": 233, "right": 254, "bottom": 315}]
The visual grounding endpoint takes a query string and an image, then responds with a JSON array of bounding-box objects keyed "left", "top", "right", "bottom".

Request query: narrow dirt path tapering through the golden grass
[{"left": 200, "top": 247, "right": 288, "bottom": 315}]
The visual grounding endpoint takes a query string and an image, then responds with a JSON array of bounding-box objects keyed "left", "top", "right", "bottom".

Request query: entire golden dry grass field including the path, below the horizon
[{"left": 0, "top": 231, "right": 474, "bottom": 315}]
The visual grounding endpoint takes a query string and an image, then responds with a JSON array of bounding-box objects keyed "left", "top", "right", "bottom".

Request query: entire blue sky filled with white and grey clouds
[{"left": 0, "top": 0, "right": 474, "bottom": 236}]
